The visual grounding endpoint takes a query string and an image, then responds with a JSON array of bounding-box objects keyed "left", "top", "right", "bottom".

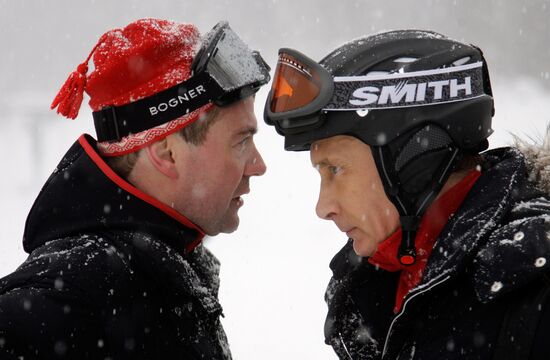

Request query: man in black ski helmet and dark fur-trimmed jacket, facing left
[{"left": 265, "top": 30, "right": 550, "bottom": 359}]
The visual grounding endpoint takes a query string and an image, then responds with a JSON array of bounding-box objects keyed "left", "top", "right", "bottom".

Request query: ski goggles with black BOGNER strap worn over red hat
[{"left": 93, "top": 21, "right": 270, "bottom": 141}]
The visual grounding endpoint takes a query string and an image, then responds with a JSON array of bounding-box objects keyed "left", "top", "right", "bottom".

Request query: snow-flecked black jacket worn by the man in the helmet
[{"left": 325, "top": 148, "right": 550, "bottom": 360}]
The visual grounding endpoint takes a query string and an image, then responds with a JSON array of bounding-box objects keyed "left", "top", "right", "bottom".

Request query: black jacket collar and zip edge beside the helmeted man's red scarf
[{"left": 382, "top": 149, "right": 536, "bottom": 359}]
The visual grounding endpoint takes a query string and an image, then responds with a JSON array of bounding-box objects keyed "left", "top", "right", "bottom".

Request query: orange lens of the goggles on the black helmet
[{"left": 270, "top": 53, "right": 321, "bottom": 113}]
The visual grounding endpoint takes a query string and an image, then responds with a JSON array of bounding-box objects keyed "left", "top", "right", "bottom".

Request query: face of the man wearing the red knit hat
[{"left": 174, "top": 97, "right": 266, "bottom": 236}]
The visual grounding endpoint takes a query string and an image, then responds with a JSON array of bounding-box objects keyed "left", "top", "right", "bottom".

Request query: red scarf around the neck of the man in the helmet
[{"left": 368, "top": 170, "right": 481, "bottom": 313}]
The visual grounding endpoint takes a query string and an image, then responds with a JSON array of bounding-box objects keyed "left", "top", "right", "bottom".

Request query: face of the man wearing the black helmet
[{"left": 310, "top": 136, "right": 399, "bottom": 256}]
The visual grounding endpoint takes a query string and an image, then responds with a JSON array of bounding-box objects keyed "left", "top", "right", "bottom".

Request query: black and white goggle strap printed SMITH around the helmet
[{"left": 324, "top": 61, "right": 490, "bottom": 111}]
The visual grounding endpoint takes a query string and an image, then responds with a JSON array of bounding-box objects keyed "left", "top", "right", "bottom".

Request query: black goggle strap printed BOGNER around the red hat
[{"left": 93, "top": 72, "right": 224, "bottom": 142}]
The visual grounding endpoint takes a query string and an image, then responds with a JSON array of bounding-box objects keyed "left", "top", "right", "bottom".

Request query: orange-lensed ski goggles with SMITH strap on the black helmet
[{"left": 264, "top": 48, "right": 485, "bottom": 135}]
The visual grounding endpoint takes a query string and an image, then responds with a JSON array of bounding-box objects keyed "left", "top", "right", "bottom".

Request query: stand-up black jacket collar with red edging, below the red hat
[{"left": 23, "top": 135, "right": 204, "bottom": 253}]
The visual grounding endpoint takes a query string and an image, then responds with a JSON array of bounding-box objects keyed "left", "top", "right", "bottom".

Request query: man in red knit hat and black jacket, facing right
[{"left": 0, "top": 19, "right": 269, "bottom": 359}]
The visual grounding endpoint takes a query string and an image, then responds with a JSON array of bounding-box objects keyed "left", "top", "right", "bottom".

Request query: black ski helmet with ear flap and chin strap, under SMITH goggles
[{"left": 265, "top": 30, "right": 494, "bottom": 264}]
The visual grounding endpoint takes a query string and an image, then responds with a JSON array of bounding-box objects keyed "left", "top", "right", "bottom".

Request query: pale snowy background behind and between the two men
[{"left": 0, "top": 0, "right": 550, "bottom": 360}]
